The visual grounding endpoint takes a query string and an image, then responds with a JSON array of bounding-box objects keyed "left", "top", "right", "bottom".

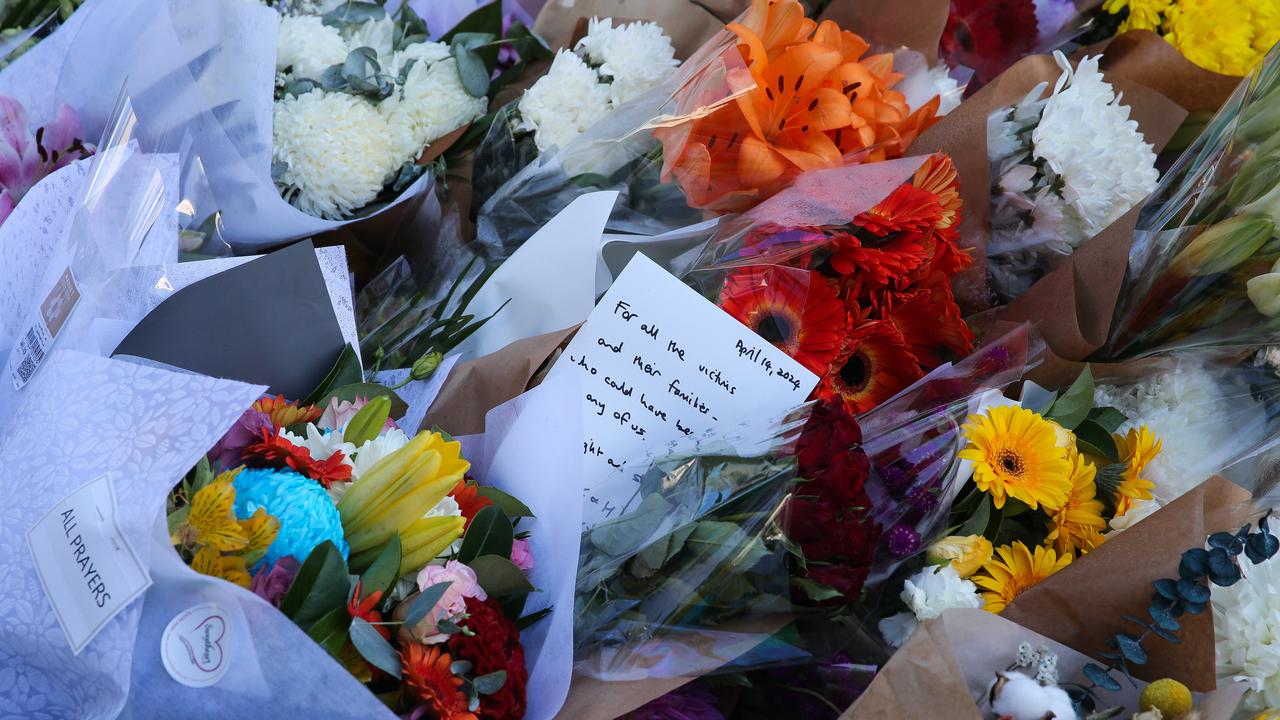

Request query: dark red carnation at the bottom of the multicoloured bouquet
[{"left": 448, "top": 597, "right": 529, "bottom": 720}]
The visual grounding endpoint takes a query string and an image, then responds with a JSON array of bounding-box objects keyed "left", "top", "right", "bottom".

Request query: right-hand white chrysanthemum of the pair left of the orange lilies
[{"left": 577, "top": 18, "right": 680, "bottom": 108}]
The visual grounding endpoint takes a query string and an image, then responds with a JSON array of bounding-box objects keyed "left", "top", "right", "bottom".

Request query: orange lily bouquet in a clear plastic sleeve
[{"left": 479, "top": 0, "right": 938, "bottom": 258}]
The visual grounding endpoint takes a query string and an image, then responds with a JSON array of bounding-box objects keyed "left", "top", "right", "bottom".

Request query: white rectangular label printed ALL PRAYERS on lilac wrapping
[{"left": 27, "top": 474, "right": 151, "bottom": 655}]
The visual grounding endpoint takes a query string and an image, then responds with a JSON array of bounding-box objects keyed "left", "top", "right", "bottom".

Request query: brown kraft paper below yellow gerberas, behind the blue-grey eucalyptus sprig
[{"left": 1002, "top": 477, "right": 1251, "bottom": 692}]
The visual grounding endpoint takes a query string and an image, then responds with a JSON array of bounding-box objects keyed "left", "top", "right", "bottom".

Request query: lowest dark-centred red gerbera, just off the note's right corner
[{"left": 814, "top": 320, "right": 923, "bottom": 414}]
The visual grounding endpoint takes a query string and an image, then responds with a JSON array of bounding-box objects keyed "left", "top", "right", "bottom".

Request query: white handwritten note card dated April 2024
[{"left": 552, "top": 254, "right": 818, "bottom": 527}]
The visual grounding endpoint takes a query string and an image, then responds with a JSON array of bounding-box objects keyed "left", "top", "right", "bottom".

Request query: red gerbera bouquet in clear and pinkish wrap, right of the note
[{"left": 694, "top": 154, "right": 973, "bottom": 414}]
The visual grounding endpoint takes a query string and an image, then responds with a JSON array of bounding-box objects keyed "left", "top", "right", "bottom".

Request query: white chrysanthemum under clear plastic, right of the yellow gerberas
[{"left": 1093, "top": 363, "right": 1265, "bottom": 505}]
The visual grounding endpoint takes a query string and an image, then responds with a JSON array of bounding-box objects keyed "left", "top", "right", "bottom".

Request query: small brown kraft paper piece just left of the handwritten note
[{"left": 422, "top": 325, "right": 577, "bottom": 436}]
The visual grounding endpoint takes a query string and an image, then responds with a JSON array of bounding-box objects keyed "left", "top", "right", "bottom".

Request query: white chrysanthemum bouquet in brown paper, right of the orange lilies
[{"left": 987, "top": 53, "right": 1158, "bottom": 301}]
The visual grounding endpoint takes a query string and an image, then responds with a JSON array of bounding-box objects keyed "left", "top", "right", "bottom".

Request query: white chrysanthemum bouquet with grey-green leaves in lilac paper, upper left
[{"left": 271, "top": 1, "right": 488, "bottom": 220}]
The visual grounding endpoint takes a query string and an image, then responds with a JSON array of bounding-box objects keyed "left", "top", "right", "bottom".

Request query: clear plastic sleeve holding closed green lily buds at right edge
[{"left": 1101, "top": 44, "right": 1280, "bottom": 360}]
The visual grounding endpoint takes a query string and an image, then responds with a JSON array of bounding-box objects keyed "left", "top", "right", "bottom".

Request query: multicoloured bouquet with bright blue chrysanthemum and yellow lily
[{"left": 169, "top": 386, "right": 547, "bottom": 719}]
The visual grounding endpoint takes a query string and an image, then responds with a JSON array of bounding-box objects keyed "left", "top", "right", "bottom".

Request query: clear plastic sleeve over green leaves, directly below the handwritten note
[{"left": 573, "top": 409, "right": 805, "bottom": 680}]
